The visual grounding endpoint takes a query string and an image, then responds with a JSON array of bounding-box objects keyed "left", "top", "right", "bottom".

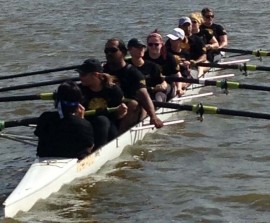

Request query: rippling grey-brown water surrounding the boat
[{"left": 0, "top": 0, "right": 270, "bottom": 223}]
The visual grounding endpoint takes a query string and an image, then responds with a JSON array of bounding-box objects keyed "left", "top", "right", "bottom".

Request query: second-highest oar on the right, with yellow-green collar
[{"left": 196, "top": 63, "right": 270, "bottom": 71}]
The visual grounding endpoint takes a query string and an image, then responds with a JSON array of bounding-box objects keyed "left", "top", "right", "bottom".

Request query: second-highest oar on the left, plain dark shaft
[{"left": 0, "top": 77, "right": 79, "bottom": 92}]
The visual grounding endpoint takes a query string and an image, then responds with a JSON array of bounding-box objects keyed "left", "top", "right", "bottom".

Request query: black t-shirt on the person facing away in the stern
[{"left": 34, "top": 112, "right": 94, "bottom": 158}]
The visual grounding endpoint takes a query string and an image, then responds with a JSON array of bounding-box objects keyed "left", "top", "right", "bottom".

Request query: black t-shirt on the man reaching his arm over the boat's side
[{"left": 104, "top": 63, "right": 146, "bottom": 99}]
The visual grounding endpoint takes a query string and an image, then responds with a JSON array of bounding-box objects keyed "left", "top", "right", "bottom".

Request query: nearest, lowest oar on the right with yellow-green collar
[{"left": 153, "top": 101, "right": 270, "bottom": 119}]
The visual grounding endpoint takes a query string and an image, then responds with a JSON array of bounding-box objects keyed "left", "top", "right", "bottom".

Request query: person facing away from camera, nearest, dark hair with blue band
[{"left": 34, "top": 82, "right": 94, "bottom": 159}]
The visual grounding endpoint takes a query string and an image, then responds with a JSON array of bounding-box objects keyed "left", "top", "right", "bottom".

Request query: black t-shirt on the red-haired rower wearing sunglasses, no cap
[{"left": 143, "top": 51, "right": 179, "bottom": 76}]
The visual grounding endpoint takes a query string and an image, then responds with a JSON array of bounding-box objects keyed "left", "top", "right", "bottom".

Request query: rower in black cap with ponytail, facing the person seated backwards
[{"left": 76, "top": 59, "right": 127, "bottom": 149}]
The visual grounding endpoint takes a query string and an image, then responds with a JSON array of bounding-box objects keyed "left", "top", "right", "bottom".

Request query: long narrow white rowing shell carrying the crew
[{"left": 3, "top": 58, "right": 247, "bottom": 217}]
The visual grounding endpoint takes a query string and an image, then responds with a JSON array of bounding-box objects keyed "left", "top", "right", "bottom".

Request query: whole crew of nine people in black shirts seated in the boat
[{"left": 34, "top": 8, "right": 227, "bottom": 159}]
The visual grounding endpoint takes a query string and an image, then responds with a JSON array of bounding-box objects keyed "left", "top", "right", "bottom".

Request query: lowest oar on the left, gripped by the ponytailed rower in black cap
[{"left": 0, "top": 107, "right": 117, "bottom": 131}]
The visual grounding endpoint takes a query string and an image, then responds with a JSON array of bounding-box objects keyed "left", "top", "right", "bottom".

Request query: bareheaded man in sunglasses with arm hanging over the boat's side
[{"left": 104, "top": 38, "right": 163, "bottom": 133}]
